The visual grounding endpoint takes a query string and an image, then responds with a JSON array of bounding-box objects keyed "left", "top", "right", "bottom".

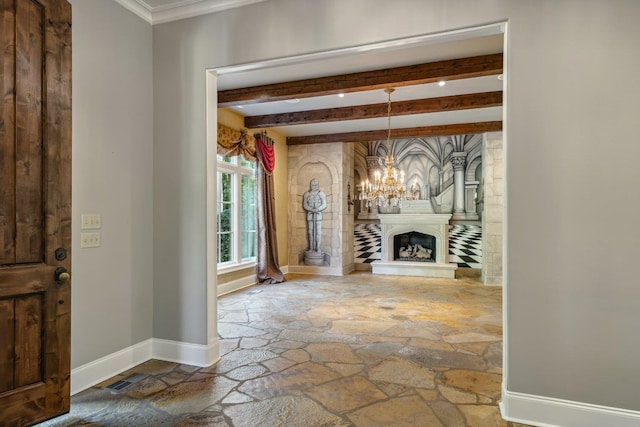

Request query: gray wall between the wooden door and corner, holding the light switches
[{"left": 71, "top": 0, "right": 153, "bottom": 368}]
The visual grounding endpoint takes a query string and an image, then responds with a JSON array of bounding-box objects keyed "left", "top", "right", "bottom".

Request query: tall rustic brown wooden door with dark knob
[{"left": 0, "top": 0, "right": 71, "bottom": 426}]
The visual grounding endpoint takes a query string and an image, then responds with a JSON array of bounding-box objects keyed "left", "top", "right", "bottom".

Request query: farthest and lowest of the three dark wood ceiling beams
[{"left": 287, "top": 121, "right": 502, "bottom": 145}]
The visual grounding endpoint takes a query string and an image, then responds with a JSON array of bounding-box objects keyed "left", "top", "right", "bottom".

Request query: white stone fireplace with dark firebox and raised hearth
[{"left": 371, "top": 213, "right": 458, "bottom": 278}]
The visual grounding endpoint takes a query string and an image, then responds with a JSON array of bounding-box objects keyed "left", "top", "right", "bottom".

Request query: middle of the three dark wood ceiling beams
[{"left": 244, "top": 91, "right": 502, "bottom": 129}]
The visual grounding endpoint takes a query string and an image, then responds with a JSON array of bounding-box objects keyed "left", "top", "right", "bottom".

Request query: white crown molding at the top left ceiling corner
[{"left": 115, "top": 0, "right": 266, "bottom": 25}]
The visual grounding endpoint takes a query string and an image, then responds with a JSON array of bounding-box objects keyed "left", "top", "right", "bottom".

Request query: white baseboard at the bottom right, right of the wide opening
[{"left": 500, "top": 384, "right": 640, "bottom": 427}]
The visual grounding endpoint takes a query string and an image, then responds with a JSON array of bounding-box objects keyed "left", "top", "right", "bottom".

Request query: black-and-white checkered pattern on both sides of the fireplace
[{"left": 353, "top": 223, "right": 482, "bottom": 268}]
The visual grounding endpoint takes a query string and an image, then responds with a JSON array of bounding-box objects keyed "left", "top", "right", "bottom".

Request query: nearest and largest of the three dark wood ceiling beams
[{"left": 218, "top": 53, "right": 502, "bottom": 107}]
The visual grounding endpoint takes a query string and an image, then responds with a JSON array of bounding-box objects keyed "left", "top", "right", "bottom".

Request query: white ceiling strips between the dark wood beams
[{"left": 217, "top": 32, "right": 504, "bottom": 137}]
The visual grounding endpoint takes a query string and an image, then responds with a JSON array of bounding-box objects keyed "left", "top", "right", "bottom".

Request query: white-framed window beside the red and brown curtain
[{"left": 216, "top": 155, "right": 257, "bottom": 268}]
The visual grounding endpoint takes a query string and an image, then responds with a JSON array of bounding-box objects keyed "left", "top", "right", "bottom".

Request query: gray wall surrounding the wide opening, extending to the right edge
[{"left": 153, "top": 0, "right": 640, "bottom": 410}]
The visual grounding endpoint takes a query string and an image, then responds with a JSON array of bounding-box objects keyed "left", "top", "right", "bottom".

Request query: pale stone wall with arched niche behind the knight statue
[{"left": 288, "top": 143, "right": 354, "bottom": 275}]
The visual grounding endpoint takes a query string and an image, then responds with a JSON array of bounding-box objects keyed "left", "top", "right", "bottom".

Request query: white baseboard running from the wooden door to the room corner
[{"left": 71, "top": 339, "right": 152, "bottom": 395}]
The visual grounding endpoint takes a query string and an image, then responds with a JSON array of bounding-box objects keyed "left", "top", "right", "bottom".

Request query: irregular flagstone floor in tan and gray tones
[{"left": 41, "top": 272, "right": 521, "bottom": 427}]
